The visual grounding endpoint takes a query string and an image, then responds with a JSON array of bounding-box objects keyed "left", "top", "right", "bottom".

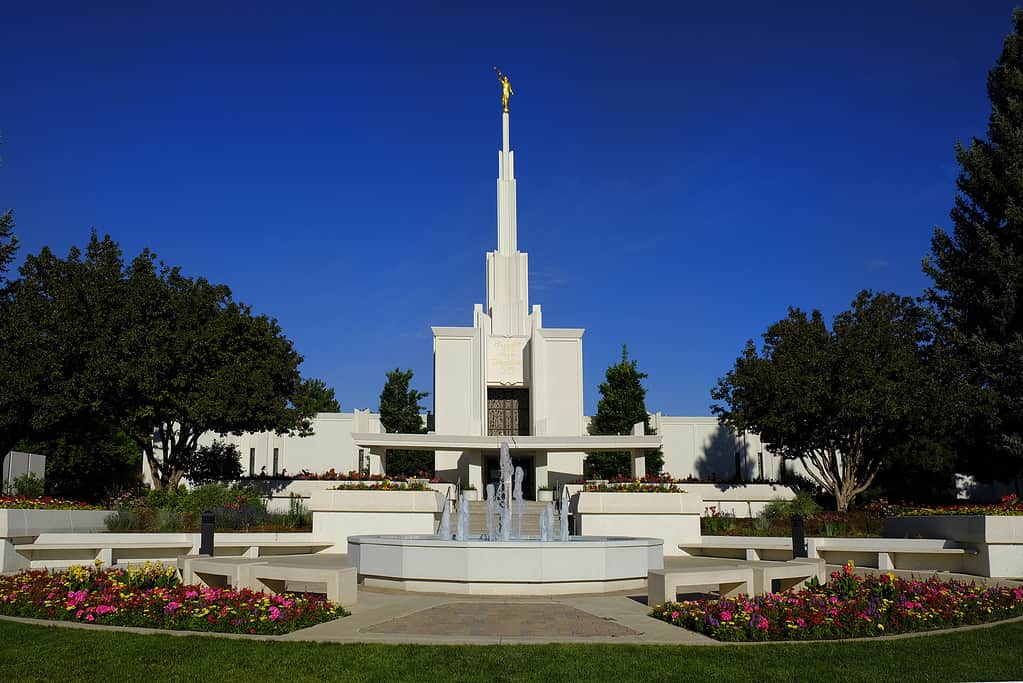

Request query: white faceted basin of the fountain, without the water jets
[{"left": 348, "top": 535, "right": 664, "bottom": 595}]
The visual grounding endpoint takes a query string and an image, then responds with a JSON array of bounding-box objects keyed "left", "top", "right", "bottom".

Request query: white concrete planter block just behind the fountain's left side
[{"left": 309, "top": 491, "right": 445, "bottom": 552}]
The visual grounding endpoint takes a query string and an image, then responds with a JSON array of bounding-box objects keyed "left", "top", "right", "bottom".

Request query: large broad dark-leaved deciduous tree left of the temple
[{"left": 4, "top": 234, "right": 310, "bottom": 488}]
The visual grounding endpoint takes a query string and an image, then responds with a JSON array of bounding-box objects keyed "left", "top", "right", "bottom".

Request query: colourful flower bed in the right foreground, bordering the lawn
[{"left": 651, "top": 562, "right": 1023, "bottom": 641}]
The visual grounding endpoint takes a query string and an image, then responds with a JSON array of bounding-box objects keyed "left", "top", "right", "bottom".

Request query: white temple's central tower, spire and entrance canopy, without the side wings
[{"left": 353, "top": 104, "right": 662, "bottom": 495}]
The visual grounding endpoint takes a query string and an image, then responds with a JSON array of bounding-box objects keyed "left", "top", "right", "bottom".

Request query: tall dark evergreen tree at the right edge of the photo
[{"left": 924, "top": 9, "right": 1023, "bottom": 487}]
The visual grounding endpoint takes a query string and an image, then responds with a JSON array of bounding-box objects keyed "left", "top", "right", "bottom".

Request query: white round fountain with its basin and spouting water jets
[{"left": 348, "top": 443, "right": 664, "bottom": 595}]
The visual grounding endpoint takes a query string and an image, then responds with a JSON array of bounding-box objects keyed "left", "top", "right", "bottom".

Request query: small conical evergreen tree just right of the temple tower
[{"left": 584, "top": 344, "right": 664, "bottom": 477}]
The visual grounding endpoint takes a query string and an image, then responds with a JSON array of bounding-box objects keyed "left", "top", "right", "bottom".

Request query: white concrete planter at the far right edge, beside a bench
[{"left": 885, "top": 514, "right": 1023, "bottom": 578}]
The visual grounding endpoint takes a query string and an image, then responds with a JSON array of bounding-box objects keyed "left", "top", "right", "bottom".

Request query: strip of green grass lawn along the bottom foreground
[{"left": 0, "top": 621, "right": 1023, "bottom": 683}]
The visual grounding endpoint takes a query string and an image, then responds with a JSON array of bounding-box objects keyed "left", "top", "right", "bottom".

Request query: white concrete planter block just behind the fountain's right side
[{"left": 572, "top": 492, "right": 703, "bottom": 555}]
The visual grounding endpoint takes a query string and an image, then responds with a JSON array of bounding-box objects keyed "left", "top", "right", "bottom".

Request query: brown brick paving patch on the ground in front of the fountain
[{"left": 364, "top": 602, "right": 640, "bottom": 639}]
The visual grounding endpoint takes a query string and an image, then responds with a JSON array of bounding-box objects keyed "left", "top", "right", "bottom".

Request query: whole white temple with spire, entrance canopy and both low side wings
[{"left": 155, "top": 89, "right": 783, "bottom": 498}]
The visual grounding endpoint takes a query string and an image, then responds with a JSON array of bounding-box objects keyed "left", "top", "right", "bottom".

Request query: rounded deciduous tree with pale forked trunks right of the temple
[{"left": 711, "top": 291, "right": 940, "bottom": 510}]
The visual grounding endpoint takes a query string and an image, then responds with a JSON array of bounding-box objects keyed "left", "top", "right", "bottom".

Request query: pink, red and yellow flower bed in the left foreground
[{"left": 0, "top": 562, "right": 348, "bottom": 635}]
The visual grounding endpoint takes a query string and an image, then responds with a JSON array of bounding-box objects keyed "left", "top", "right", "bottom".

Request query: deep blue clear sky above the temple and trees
[{"left": 0, "top": 0, "right": 1013, "bottom": 415}]
